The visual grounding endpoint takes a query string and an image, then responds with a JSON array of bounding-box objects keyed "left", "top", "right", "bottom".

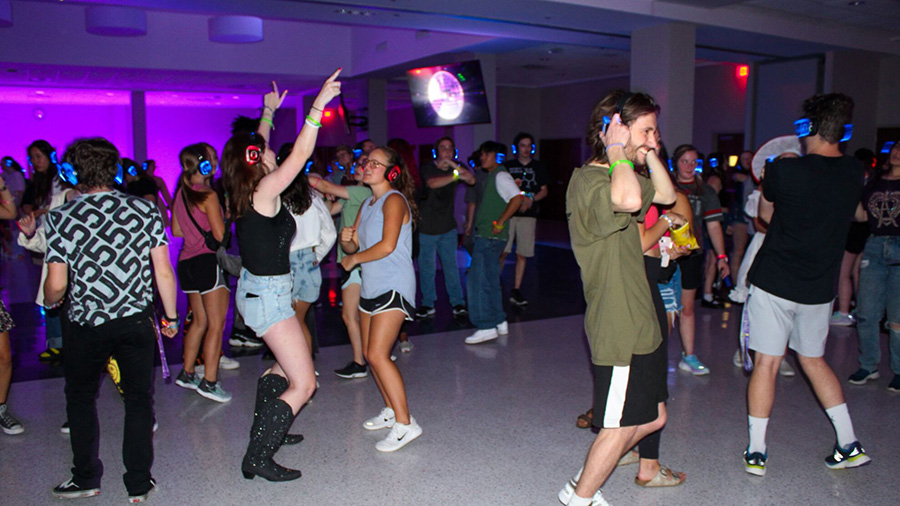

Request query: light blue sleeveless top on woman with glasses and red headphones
[{"left": 356, "top": 190, "right": 416, "bottom": 305}]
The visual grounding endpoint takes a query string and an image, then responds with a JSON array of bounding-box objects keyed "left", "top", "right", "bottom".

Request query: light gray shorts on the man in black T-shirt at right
[{"left": 746, "top": 285, "right": 831, "bottom": 358}]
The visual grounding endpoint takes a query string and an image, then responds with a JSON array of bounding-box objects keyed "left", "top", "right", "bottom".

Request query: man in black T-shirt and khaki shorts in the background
[{"left": 500, "top": 132, "right": 550, "bottom": 306}]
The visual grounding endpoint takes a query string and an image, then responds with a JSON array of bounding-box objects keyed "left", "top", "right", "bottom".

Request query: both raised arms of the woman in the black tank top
[{"left": 254, "top": 69, "right": 341, "bottom": 204}]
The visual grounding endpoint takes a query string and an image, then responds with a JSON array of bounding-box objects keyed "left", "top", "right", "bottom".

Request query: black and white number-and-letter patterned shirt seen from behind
[{"left": 45, "top": 191, "right": 169, "bottom": 327}]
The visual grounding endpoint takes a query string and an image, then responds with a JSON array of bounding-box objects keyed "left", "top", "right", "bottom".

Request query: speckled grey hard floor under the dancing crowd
[{"left": 0, "top": 226, "right": 900, "bottom": 506}]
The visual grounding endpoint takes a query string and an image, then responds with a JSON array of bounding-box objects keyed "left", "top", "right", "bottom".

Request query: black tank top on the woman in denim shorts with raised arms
[{"left": 235, "top": 205, "right": 297, "bottom": 276}]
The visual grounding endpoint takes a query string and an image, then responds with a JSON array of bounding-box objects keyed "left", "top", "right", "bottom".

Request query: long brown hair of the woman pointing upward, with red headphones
[{"left": 222, "top": 132, "right": 268, "bottom": 219}]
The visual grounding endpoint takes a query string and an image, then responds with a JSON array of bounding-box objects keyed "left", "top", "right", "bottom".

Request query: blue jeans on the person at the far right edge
[{"left": 856, "top": 235, "right": 900, "bottom": 374}]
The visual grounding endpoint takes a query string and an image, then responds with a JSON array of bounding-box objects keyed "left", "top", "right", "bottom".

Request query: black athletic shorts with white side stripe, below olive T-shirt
[{"left": 593, "top": 344, "right": 668, "bottom": 429}]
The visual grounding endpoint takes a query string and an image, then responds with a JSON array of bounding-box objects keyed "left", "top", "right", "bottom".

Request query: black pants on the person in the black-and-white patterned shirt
[{"left": 64, "top": 311, "right": 156, "bottom": 495}]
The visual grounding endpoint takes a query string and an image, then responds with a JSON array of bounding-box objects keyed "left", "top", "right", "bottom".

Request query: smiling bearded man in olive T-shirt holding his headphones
[{"left": 558, "top": 90, "right": 681, "bottom": 506}]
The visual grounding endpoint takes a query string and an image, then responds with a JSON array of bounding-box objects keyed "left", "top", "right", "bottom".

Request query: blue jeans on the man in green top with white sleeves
[{"left": 466, "top": 237, "right": 506, "bottom": 329}]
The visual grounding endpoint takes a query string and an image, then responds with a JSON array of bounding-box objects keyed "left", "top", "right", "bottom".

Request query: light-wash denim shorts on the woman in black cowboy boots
[{"left": 234, "top": 269, "right": 294, "bottom": 336}]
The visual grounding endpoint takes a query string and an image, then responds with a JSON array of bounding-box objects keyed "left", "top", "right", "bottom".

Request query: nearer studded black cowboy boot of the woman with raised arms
[{"left": 241, "top": 399, "right": 301, "bottom": 481}]
